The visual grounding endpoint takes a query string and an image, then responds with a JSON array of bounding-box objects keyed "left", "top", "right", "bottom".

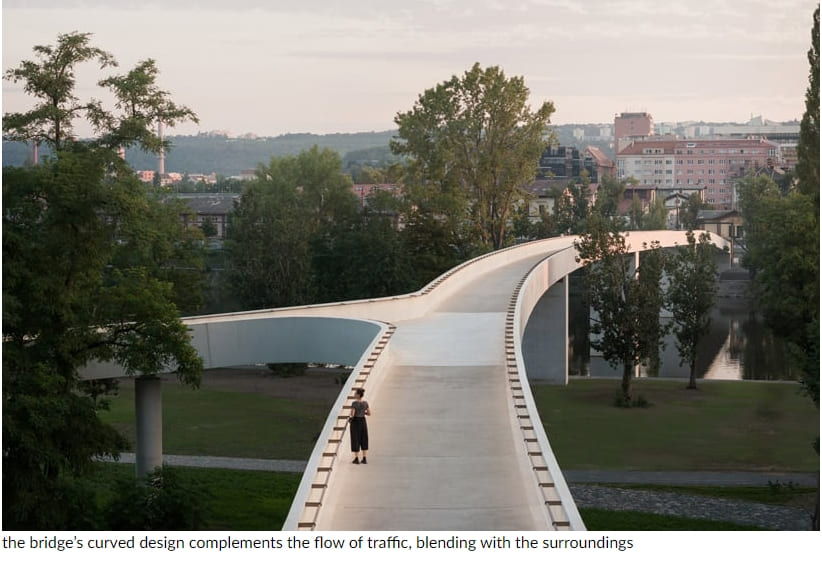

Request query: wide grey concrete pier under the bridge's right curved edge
[{"left": 522, "top": 276, "right": 568, "bottom": 385}]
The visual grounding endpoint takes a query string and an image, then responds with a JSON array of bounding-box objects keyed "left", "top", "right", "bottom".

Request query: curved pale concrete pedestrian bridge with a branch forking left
[{"left": 80, "top": 231, "right": 724, "bottom": 531}]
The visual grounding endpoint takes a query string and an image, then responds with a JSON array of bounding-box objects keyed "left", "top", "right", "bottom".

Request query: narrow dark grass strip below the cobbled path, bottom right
[{"left": 579, "top": 508, "right": 762, "bottom": 532}]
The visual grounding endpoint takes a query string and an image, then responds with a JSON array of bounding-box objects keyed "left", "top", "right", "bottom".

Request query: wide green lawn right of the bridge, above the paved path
[{"left": 533, "top": 379, "right": 819, "bottom": 472}]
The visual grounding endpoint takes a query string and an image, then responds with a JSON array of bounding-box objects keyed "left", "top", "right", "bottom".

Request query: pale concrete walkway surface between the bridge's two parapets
[{"left": 317, "top": 253, "right": 551, "bottom": 530}]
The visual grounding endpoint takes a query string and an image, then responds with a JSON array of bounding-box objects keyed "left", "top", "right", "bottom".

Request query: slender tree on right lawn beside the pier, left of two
[{"left": 574, "top": 214, "right": 665, "bottom": 406}]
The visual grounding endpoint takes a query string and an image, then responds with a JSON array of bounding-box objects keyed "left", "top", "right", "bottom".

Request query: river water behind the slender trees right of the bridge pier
[{"left": 568, "top": 277, "right": 798, "bottom": 380}]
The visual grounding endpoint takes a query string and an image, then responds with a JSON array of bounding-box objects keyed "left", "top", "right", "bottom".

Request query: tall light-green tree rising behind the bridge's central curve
[{"left": 391, "top": 63, "right": 554, "bottom": 249}]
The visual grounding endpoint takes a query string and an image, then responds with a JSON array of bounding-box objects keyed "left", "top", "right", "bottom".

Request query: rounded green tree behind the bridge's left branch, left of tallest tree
[{"left": 226, "top": 146, "right": 357, "bottom": 308}]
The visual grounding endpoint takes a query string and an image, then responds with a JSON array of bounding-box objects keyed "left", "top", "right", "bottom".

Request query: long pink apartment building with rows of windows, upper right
[{"left": 616, "top": 138, "right": 782, "bottom": 209}]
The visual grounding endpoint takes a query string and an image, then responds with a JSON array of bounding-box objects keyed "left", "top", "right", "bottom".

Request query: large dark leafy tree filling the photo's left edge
[{"left": 3, "top": 33, "right": 202, "bottom": 530}]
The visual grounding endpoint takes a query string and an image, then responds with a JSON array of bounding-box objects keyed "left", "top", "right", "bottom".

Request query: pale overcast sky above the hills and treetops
[{"left": 2, "top": 0, "right": 818, "bottom": 135}]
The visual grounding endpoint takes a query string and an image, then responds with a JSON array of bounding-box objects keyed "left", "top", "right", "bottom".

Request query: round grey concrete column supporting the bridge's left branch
[{"left": 134, "top": 375, "right": 163, "bottom": 477}]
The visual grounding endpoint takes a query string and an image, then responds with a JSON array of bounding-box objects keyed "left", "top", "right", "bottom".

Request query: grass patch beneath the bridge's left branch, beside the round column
[{"left": 101, "top": 381, "right": 330, "bottom": 460}]
